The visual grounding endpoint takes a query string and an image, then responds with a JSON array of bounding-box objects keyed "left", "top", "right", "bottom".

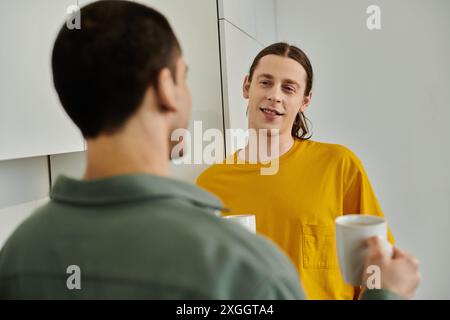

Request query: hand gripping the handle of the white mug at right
[{"left": 363, "top": 237, "right": 420, "bottom": 299}]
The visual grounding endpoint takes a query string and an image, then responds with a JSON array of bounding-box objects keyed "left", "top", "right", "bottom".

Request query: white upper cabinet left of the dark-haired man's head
[{"left": 0, "top": 0, "right": 84, "bottom": 160}]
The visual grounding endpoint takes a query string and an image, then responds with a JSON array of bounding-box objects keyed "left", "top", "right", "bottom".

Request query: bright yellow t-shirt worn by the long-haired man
[{"left": 197, "top": 139, "right": 394, "bottom": 299}]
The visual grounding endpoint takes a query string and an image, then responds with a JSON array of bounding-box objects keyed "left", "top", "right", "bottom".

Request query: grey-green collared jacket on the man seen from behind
[{"left": 0, "top": 174, "right": 400, "bottom": 299}]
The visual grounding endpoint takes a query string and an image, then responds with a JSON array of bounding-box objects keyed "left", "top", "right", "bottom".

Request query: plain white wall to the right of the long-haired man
[{"left": 276, "top": 0, "right": 450, "bottom": 299}]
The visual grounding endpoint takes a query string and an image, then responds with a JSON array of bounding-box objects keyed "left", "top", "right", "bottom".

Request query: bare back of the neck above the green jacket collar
[{"left": 84, "top": 122, "right": 170, "bottom": 180}]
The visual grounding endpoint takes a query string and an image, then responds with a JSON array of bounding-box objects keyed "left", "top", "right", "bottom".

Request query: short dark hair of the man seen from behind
[{"left": 52, "top": 0, "right": 181, "bottom": 138}]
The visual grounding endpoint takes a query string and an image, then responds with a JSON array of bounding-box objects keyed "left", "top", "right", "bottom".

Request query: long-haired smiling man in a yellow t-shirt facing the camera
[{"left": 197, "top": 43, "right": 394, "bottom": 299}]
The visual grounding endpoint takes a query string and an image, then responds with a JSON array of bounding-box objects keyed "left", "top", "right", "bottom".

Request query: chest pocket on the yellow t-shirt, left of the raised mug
[{"left": 300, "top": 224, "right": 339, "bottom": 269}]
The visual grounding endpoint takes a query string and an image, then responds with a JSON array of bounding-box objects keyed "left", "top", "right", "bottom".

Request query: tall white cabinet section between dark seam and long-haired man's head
[{"left": 218, "top": 0, "right": 276, "bottom": 154}]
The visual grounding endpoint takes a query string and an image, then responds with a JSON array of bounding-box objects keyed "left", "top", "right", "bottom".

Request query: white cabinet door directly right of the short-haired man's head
[{"left": 136, "top": 0, "right": 223, "bottom": 181}]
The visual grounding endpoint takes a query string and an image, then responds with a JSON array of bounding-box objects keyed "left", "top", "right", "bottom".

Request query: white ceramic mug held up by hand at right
[{"left": 335, "top": 214, "right": 392, "bottom": 286}]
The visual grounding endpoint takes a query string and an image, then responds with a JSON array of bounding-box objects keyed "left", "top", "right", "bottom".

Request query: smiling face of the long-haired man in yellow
[{"left": 243, "top": 54, "right": 309, "bottom": 136}]
